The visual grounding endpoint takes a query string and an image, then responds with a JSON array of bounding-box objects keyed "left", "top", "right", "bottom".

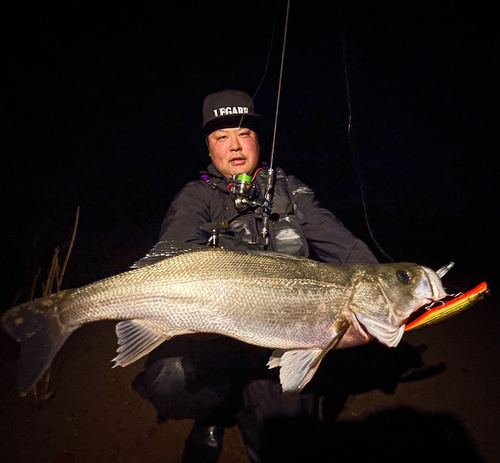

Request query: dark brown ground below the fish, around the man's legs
[{"left": 0, "top": 282, "right": 500, "bottom": 463}]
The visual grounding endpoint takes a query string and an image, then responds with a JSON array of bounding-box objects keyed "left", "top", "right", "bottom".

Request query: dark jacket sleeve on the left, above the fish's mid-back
[{"left": 160, "top": 180, "right": 210, "bottom": 245}]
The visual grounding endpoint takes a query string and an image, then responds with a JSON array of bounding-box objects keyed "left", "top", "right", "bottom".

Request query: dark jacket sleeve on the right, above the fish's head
[{"left": 288, "top": 176, "right": 378, "bottom": 264}]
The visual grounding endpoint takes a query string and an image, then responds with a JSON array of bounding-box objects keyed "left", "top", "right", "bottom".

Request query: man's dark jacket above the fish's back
[{"left": 160, "top": 164, "right": 377, "bottom": 264}]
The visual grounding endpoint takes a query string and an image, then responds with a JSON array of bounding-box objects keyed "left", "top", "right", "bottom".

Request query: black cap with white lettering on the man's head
[{"left": 203, "top": 90, "right": 261, "bottom": 135}]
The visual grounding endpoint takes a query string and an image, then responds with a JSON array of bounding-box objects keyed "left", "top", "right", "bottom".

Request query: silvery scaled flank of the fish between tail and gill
[{"left": 61, "top": 250, "right": 352, "bottom": 348}]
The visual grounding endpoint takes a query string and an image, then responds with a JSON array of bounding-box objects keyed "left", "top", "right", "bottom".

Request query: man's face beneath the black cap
[{"left": 208, "top": 127, "right": 260, "bottom": 178}]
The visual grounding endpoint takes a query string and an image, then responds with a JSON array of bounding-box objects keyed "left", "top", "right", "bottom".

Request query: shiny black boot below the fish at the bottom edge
[{"left": 182, "top": 422, "right": 224, "bottom": 463}]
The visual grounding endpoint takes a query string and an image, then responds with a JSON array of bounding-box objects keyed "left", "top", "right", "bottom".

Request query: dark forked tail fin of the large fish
[{"left": 2, "top": 290, "right": 78, "bottom": 396}]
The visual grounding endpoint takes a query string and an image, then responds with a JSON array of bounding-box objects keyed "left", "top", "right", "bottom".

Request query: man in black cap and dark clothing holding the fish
[{"left": 134, "top": 90, "right": 377, "bottom": 463}]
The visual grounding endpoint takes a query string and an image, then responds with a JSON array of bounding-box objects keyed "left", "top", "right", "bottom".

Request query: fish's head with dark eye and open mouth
[{"left": 351, "top": 262, "right": 446, "bottom": 346}]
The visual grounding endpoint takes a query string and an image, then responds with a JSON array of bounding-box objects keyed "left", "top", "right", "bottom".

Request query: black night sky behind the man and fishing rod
[{"left": 0, "top": 0, "right": 500, "bottom": 308}]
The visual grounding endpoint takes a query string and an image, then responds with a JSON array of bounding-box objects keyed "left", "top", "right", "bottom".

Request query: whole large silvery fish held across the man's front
[{"left": 2, "top": 242, "right": 446, "bottom": 395}]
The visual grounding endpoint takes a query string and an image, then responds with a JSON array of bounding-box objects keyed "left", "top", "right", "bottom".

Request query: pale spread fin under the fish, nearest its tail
[{"left": 112, "top": 320, "right": 172, "bottom": 368}]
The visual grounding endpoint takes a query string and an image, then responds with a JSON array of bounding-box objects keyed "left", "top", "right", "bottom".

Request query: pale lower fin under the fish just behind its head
[{"left": 267, "top": 320, "right": 349, "bottom": 393}]
